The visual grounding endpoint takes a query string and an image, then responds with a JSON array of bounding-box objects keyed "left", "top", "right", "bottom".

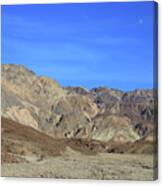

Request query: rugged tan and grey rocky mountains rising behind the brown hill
[{"left": 1, "top": 64, "right": 157, "bottom": 143}]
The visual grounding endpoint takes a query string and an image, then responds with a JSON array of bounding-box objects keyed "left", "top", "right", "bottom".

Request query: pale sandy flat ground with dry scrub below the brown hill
[{"left": 2, "top": 147, "right": 157, "bottom": 180}]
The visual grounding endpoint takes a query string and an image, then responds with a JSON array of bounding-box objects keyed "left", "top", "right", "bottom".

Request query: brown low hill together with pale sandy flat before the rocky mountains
[{"left": 1, "top": 118, "right": 157, "bottom": 180}]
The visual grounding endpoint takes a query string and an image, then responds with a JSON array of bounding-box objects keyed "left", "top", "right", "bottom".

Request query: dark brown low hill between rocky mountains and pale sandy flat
[{"left": 1, "top": 118, "right": 155, "bottom": 163}]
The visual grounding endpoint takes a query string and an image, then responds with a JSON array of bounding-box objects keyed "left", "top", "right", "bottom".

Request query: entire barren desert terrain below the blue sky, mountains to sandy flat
[{"left": 1, "top": 64, "right": 157, "bottom": 180}]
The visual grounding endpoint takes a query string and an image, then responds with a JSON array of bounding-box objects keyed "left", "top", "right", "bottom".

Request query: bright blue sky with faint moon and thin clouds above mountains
[{"left": 2, "top": 2, "right": 157, "bottom": 90}]
